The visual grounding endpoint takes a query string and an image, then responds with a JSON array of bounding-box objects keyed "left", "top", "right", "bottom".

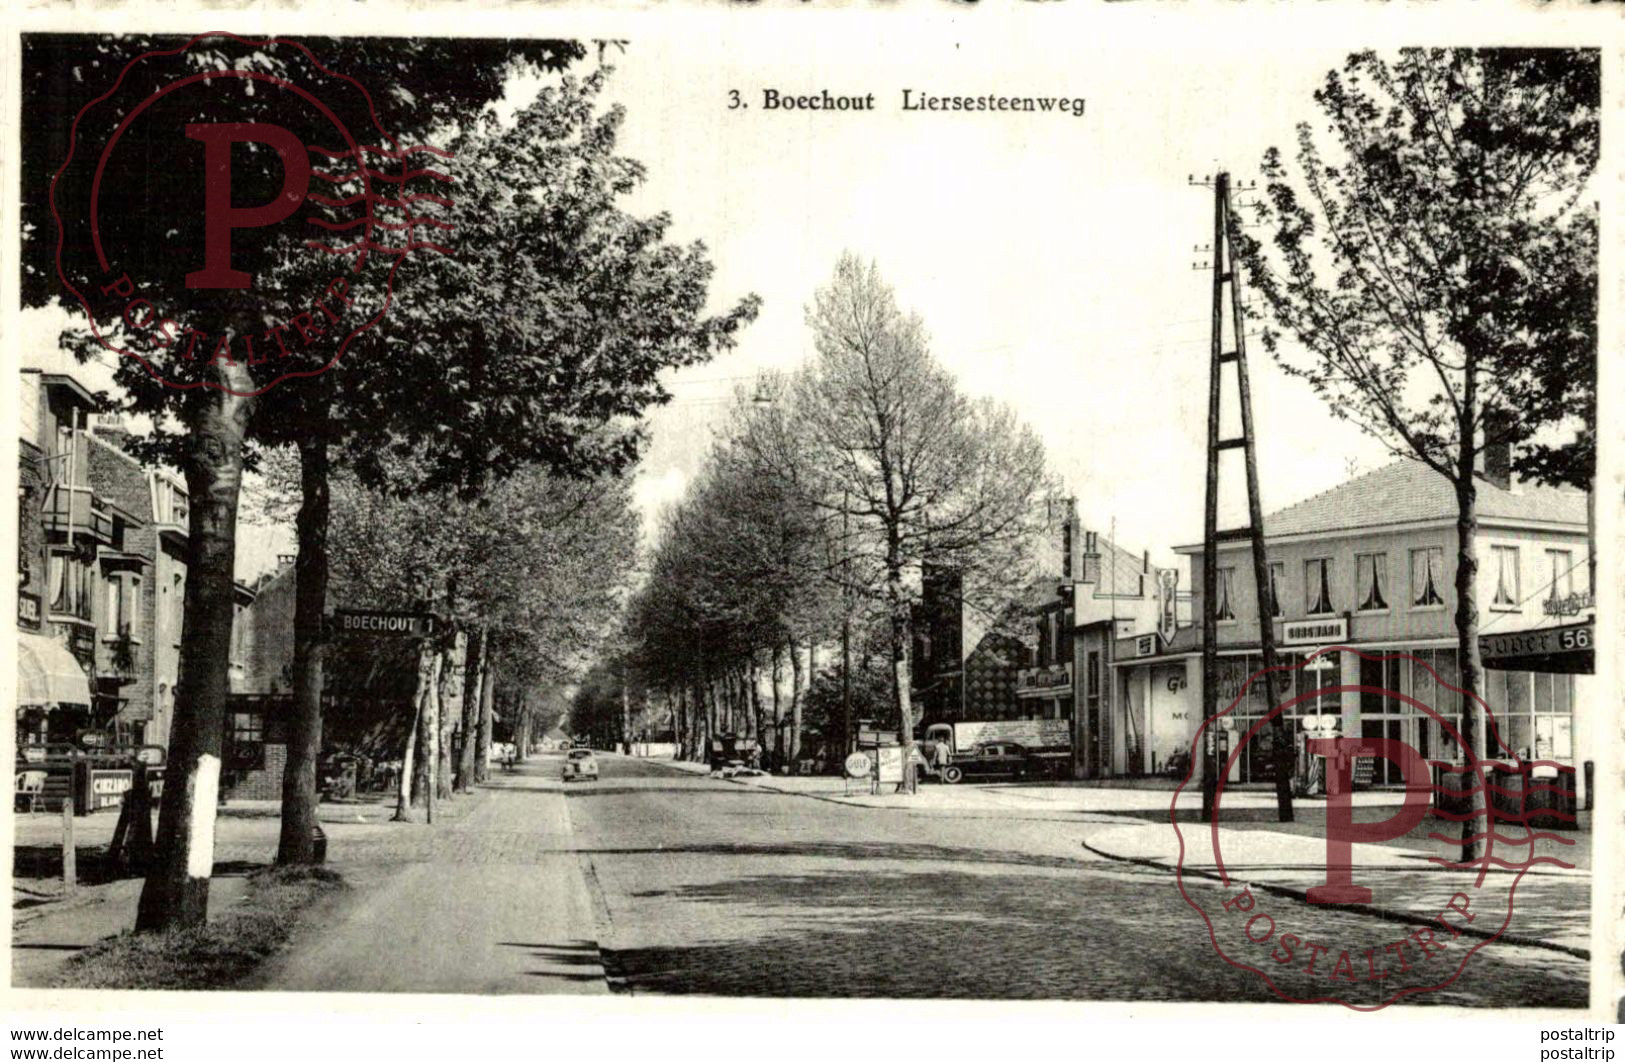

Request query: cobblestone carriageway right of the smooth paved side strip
[{"left": 564, "top": 757, "right": 1588, "bottom": 1008}]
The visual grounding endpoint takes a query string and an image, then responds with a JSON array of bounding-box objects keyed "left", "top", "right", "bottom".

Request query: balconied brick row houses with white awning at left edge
[{"left": 18, "top": 370, "right": 187, "bottom": 749}]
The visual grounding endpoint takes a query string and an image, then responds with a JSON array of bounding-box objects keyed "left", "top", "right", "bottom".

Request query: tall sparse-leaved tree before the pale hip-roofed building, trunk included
[{"left": 1240, "top": 49, "right": 1599, "bottom": 861}]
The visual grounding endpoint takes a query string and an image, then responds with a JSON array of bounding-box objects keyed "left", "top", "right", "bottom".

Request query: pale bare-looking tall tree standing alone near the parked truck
[{"left": 767, "top": 255, "right": 1053, "bottom": 789}]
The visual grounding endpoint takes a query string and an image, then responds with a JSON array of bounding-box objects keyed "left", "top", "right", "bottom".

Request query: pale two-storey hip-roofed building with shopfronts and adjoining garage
[{"left": 1110, "top": 453, "right": 1593, "bottom": 798}]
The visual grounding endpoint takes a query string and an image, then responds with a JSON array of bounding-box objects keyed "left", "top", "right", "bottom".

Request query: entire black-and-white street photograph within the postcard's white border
[{"left": 10, "top": 32, "right": 1619, "bottom": 1013}]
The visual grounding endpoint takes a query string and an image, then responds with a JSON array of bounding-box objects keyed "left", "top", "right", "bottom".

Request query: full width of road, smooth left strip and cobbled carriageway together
[{"left": 265, "top": 757, "right": 1586, "bottom": 1007}]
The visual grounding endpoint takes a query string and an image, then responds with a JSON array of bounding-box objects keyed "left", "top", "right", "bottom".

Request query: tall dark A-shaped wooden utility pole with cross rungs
[{"left": 1193, "top": 172, "right": 1294, "bottom": 822}]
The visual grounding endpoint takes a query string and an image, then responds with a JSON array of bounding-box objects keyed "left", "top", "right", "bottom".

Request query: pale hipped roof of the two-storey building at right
[{"left": 1180, "top": 460, "right": 1586, "bottom": 552}]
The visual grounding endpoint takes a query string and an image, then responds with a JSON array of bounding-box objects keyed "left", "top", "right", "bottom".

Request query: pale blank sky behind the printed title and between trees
[{"left": 20, "top": 35, "right": 1410, "bottom": 578}]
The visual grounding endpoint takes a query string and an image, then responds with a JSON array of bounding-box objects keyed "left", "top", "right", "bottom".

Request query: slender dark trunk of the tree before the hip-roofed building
[{"left": 1462, "top": 428, "right": 1495, "bottom": 862}]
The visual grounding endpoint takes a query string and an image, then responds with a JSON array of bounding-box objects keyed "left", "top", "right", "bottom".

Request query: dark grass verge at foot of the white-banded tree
[{"left": 50, "top": 867, "right": 345, "bottom": 989}]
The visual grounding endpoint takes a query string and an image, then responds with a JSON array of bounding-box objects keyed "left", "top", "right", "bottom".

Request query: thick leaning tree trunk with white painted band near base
[{"left": 135, "top": 378, "right": 254, "bottom": 930}]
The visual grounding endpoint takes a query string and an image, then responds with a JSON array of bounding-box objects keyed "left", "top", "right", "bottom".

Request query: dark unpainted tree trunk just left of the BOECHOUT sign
[{"left": 276, "top": 431, "right": 330, "bottom": 866}]
